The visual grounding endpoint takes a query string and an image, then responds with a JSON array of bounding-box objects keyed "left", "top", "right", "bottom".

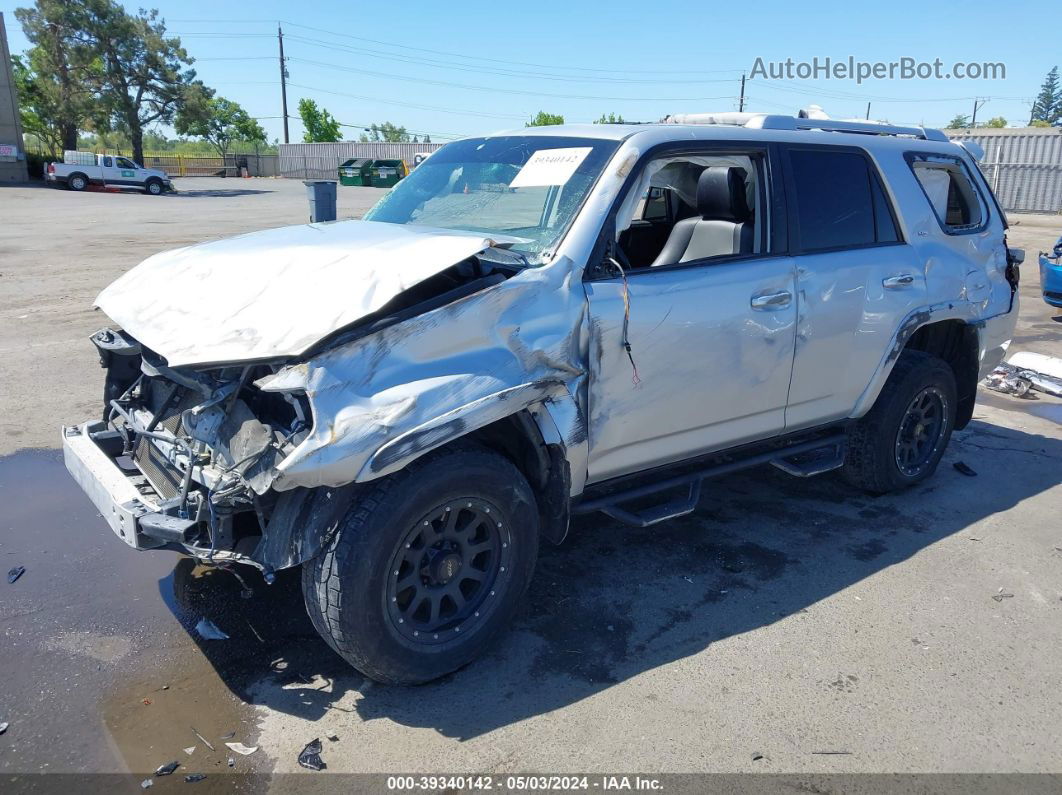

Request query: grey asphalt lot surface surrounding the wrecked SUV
[{"left": 0, "top": 178, "right": 1062, "bottom": 791}]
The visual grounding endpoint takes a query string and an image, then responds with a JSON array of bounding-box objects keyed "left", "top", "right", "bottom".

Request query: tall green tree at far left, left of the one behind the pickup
[{"left": 15, "top": 0, "right": 100, "bottom": 154}]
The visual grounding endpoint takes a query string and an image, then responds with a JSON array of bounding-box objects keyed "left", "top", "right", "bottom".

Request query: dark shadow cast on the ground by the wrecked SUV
[{"left": 160, "top": 420, "right": 1062, "bottom": 739}]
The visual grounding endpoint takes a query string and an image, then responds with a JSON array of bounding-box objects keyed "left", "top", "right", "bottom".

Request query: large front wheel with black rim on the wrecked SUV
[{"left": 303, "top": 447, "right": 538, "bottom": 685}]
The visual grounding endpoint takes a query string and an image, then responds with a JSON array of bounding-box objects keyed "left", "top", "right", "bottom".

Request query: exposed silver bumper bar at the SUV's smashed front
[{"left": 63, "top": 421, "right": 164, "bottom": 550}]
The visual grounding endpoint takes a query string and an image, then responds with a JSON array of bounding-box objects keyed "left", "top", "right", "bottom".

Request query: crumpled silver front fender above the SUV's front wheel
[{"left": 257, "top": 258, "right": 586, "bottom": 491}]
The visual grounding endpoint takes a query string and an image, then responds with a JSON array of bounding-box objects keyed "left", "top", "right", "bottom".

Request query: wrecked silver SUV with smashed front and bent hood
[{"left": 63, "top": 114, "right": 1023, "bottom": 682}]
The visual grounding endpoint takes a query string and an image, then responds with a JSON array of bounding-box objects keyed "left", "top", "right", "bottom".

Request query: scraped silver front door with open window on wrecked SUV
[{"left": 584, "top": 153, "right": 797, "bottom": 482}]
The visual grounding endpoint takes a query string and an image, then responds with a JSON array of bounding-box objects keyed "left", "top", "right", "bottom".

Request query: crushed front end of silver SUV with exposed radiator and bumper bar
[{"left": 63, "top": 329, "right": 312, "bottom": 574}]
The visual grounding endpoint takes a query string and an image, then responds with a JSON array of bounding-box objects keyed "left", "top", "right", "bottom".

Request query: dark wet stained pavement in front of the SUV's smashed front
[{"left": 0, "top": 451, "right": 333, "bottom": 792}]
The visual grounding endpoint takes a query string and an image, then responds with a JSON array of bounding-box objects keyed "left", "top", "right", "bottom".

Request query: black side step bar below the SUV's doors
[{"left": 571, "top": 433, "right": 847, "bottom": 528}]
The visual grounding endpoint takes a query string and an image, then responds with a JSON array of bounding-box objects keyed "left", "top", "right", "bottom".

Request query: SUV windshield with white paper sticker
[{"left": 365, "top": 136, "right": 618, "bottom": 264}]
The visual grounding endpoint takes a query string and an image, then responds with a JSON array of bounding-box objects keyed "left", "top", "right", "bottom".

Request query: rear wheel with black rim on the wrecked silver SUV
[{"left": 841, "top": 350, "right": 958, "bottom": 495}]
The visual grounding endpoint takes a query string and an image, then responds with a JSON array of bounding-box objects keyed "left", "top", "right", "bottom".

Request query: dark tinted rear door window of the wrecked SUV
[{"left": 789, "top": 149, "right": 900, "bottom": 252}]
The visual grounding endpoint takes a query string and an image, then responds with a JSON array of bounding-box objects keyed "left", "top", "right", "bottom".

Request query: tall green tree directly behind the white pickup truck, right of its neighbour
[{"left": 84, "top": 0, "right": 195, "bottom": 162}]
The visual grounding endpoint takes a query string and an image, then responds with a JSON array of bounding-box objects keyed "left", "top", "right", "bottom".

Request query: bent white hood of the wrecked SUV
[{"left": 96, "top": 221, "right": 511, "bottom": 367}]
